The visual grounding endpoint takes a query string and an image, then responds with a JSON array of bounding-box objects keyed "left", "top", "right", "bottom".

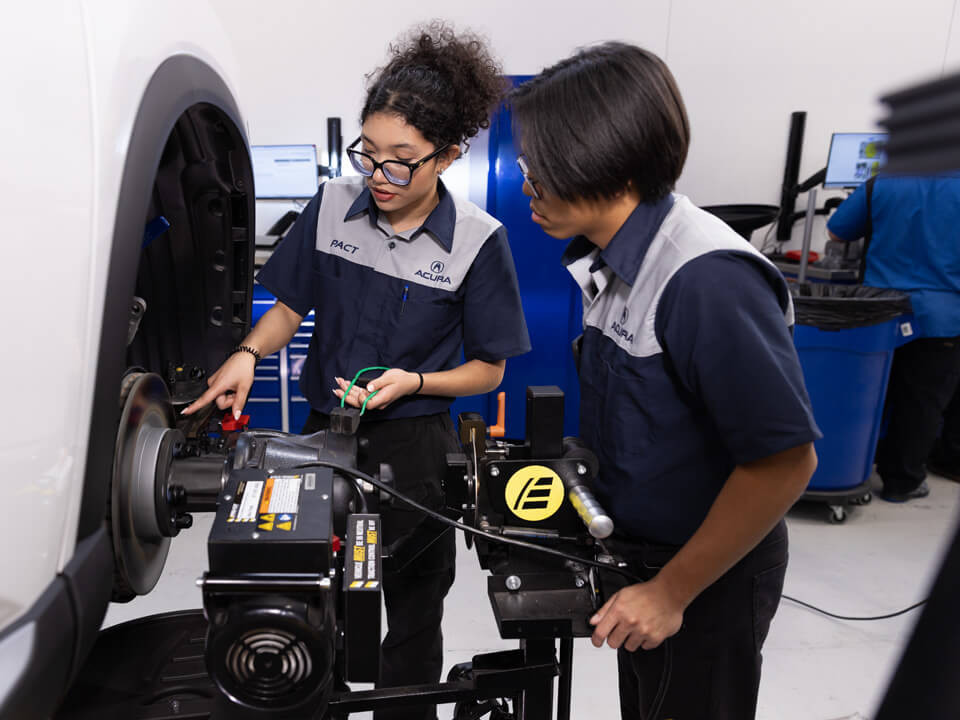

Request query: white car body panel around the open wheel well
[{"left": 0, "top": 0, "right": 252, "bottom": 717}]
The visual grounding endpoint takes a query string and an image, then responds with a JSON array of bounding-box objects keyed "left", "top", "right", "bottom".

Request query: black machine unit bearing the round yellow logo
[{"left": 447, "top": 386, "right": 612, "bottom": 639}]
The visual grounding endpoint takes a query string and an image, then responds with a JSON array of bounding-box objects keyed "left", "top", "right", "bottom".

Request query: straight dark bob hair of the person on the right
[{"left": 509, "top": 42, "right": 690, "bottom": 202}]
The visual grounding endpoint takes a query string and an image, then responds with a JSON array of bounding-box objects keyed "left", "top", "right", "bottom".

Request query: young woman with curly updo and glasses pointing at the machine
[{"left": 187, "top": 23, "right": 530, "bottom": 720}]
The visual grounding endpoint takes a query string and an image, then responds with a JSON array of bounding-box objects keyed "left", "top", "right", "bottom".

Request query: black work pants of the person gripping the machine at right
[{"left": 614, "top": 520, "right": 787, "bottom": 720}]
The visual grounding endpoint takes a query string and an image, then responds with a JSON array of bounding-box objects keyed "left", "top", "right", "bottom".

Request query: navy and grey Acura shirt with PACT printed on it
[{"left": 257, "top": 177, "right": 530, "bottom": 419}]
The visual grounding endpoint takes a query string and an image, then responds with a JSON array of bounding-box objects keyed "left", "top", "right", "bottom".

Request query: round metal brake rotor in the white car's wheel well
[{"left": 109, "top": 373, "right": 177, "bottom": 601}]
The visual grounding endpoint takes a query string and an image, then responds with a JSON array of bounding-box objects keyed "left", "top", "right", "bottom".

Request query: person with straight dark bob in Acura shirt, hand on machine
[{"left": 509, "top": 43, "right": 820, "bottom": 720}]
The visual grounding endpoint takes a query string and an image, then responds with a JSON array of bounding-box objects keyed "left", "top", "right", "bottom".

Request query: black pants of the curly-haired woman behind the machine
[{"left": 303, "top": 412, "right": 459, "bottom": 720}]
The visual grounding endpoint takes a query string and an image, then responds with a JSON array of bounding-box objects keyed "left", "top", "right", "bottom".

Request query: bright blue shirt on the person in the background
[{"left": 827, "top": 172, "right": 960, "bottom": 337}]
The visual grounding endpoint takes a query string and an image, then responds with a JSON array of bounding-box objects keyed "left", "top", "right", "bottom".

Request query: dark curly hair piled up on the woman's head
[{"left": 360, "top": 20, "right": 507, "bottom": 147}]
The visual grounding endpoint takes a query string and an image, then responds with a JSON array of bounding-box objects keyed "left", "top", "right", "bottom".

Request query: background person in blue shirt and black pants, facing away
[{"left": 827, "top": 172, "right": 960, "bottom": 502}]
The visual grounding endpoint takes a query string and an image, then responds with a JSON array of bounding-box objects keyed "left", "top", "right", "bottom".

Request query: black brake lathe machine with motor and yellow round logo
[{"left": 58, "top": 394, "right": 612, "bottom": 720}]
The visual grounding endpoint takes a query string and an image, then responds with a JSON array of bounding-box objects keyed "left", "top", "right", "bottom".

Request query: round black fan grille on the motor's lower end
[{"left": 226, "top": 628, "right": 313, "bottom": 702}]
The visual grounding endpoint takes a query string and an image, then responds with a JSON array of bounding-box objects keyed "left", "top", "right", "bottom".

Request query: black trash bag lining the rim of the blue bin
[{"left": 790, "top": 283, "right": 913, "bottom": 330}]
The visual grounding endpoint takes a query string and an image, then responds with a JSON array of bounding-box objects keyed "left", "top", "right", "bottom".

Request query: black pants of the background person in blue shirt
[{"left": 876, "top": 337, "right": 960, "bottom": 493}]
